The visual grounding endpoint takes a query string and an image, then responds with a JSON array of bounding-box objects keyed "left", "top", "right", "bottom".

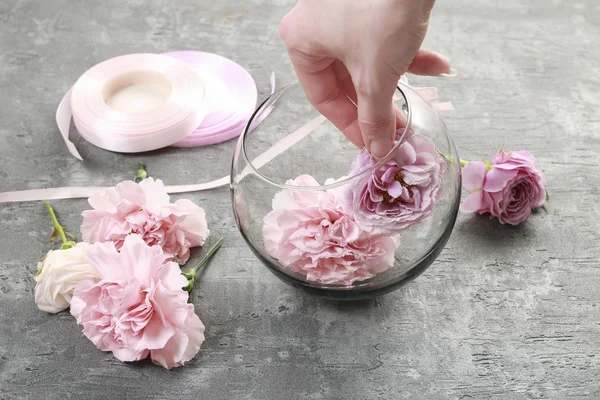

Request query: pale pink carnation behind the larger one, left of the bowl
[{"left": 81, "top": 178, "right": 209, "bottom": 264}]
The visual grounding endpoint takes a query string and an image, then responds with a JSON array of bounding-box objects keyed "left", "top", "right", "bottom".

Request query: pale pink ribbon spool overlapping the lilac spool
[{"left": 56, "top": 54, "right": 206, "bottom": 160}]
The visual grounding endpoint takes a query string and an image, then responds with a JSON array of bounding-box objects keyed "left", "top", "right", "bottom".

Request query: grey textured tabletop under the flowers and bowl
[{"left": 0, "top": 0, "right": 600, "bottom": 399}]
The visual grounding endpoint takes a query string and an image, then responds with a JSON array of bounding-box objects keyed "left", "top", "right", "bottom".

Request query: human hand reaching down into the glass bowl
[{"left": 280, "top": 0, "right": 455, "bottom": 158}]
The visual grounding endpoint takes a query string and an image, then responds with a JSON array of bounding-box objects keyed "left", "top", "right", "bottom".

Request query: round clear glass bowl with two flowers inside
[{"left": 231, "top": 83, "right": 461, "bottom": 300}]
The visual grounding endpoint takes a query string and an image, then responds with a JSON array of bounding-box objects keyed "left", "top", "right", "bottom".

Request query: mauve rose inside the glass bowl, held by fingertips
[{"left": 344, "top": 134, "right": 446, "bottom": 234}]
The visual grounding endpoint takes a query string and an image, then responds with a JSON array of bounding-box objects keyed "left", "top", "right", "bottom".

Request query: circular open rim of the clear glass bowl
[{"left": 241, "top": 81, "right": 412, "bottom": 192}]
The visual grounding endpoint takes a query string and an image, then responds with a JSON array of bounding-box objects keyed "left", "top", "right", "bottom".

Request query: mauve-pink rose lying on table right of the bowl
[{"left": 460, "top": 151, "right": 546, "bottom": 225}]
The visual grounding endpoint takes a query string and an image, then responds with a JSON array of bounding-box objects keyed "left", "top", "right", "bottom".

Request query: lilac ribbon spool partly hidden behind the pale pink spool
[{"left": 165, "top": 51, "right": 258, "bottom": 147}]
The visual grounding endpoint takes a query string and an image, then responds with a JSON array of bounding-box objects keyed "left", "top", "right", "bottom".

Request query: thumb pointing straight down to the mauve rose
[{"left": 357, "top": 85, "right": 396, "bottom": 158}]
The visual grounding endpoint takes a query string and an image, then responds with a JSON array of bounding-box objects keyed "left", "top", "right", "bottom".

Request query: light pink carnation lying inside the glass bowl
[{"left": 263, "top": 175, "right": 396, "bottom": 285}]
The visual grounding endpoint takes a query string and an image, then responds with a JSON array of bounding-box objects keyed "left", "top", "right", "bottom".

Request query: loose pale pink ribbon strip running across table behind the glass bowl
[{"left": 0, "top": 81, "right": 454, "bottom": 203}]
